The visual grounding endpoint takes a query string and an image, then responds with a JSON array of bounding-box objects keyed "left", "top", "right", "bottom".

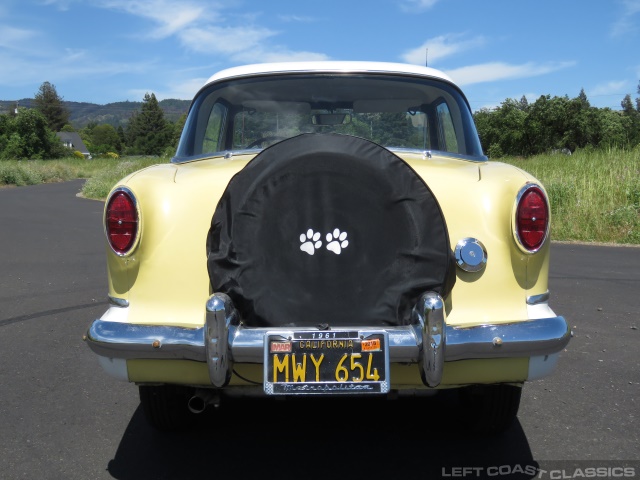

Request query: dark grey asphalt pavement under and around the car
[{"left": 0, "top": 181, "right": 640, "bottom": 480}]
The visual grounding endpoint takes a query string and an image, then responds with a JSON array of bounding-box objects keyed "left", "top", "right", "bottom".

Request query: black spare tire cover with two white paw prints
[{"left": 207, "top": 134, "right": 455, "bottom": 327}]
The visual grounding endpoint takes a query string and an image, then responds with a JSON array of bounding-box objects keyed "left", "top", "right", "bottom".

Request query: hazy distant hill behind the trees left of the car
[{"left": 0, "top": 98, "right": 191, "bottom": 129}]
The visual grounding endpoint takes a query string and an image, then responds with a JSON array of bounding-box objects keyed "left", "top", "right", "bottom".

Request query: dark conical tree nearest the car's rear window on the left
[{"left": 126, "top": 93, "right": 172, "bottom": 155}]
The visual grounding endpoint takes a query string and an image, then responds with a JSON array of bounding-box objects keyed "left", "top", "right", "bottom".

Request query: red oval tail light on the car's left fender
[{"left": 104, "top": 189, "right": 138, "bottom": 255}]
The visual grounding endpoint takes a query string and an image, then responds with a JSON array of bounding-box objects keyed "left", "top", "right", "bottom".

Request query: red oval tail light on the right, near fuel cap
[{"left": 515, "top": 185, "right": 549, "bottom": 253}]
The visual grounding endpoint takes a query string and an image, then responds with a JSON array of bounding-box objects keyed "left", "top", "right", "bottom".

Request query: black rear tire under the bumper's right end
[{"left": 460, "top": 384, "right": 522, "bottom": 435}]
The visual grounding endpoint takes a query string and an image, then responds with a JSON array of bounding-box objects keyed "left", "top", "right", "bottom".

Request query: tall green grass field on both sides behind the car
[{"left": 0, "top": 148, "right": 640, "bottom": 245}]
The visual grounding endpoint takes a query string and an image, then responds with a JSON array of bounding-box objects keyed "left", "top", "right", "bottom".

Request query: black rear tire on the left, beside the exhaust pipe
[{"left": 138, "top": 385, "right": 196, "bottom": 432}]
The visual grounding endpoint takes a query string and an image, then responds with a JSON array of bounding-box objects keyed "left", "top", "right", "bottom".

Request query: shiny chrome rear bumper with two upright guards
[{"left": 86, "top": 292, "right": 571, "bottom": 387}]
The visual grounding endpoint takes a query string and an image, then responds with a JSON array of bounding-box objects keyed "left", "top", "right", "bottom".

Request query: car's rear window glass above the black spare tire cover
[{"left": 174, "top": 74, "right": 484, "bottom": 161}]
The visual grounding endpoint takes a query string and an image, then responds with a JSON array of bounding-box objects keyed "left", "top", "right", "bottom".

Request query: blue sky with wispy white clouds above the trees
[{"left": 0, "top": 0, "right": 640, "bottom": 110}]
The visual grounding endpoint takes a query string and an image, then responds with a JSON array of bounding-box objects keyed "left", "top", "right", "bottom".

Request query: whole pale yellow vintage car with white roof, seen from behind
[{"left": 86, "top": 62, "right": 571, "bottom": 432}]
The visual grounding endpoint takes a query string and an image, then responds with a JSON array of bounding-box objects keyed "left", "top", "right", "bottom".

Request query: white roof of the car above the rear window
[{"left": 205, "top": 61, "right": 455, "bottom": 85}]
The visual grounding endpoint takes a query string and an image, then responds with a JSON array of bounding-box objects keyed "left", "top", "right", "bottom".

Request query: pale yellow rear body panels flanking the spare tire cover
[{"left": 107, "top": 154, "right": 548, "bottom": 328}]
